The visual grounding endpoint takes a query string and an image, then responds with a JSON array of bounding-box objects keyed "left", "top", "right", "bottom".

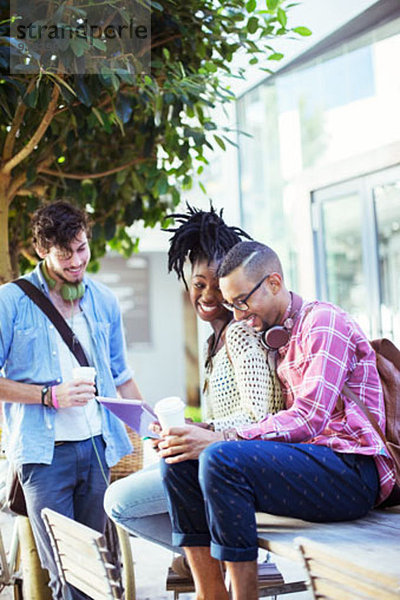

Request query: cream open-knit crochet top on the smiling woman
[{"left": 204, "top": 321, "right": 284, "bottom": 431}]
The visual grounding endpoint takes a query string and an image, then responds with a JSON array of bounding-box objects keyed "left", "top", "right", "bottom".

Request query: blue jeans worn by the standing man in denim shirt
[{"left": 20, "top": 435, "right": 108, "bottom": 600}]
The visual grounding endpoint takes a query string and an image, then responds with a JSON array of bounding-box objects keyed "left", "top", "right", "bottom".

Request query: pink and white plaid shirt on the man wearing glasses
[{"left": 238, "top": 302, "right": 395, "bottom": 503}]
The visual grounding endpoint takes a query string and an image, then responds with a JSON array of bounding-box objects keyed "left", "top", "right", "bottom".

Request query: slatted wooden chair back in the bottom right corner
[{"left": 295, "top": 537, "right": 400, "bottom": 600}]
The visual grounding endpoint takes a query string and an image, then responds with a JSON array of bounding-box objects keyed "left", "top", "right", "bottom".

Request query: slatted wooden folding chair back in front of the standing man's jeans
[{"left": 41, "top": 508, "right": 129, "bottom": 600}]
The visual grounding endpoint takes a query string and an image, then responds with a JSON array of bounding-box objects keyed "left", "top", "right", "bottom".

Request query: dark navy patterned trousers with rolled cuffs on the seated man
[{"left": 161, "top": 440, "right": 379, "bottom": 562}]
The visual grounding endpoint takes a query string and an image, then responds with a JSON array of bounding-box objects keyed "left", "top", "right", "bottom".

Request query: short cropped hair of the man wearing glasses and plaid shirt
[{"left": 217, "top": 242, "right": 283, "bottom": 281}]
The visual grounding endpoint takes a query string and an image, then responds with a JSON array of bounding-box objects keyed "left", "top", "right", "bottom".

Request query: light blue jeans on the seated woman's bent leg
[{"left": 104, "top": 463, "right": 182, "bottom": 552}]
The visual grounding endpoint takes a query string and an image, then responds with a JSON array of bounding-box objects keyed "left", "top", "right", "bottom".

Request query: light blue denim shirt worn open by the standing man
[{"left": 0, "top": 266, "right": 132, "bottom": 467}]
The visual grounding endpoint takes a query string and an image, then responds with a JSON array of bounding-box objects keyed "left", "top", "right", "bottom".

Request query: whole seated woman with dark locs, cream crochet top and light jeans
[{"left": 105, "top": 205, "right": 283, "bottom": 552}]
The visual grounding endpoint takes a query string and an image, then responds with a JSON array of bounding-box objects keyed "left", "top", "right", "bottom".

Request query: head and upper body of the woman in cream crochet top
[{"left": 163, "top": 205, "right": 283, "bottom": 434}]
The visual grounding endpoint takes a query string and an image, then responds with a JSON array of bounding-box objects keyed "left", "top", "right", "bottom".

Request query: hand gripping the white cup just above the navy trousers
[{"left": 158, "top": 425, "right": 224, "bottom": 464}]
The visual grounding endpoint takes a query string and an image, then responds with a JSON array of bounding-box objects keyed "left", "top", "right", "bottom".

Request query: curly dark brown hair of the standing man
[{"left": 31, "top": 200, "right": 91, "bottom": 251}]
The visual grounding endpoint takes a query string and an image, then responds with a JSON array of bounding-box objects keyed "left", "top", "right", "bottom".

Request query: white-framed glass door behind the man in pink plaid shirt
[{"left": 312, "top": 167, "right": 400, "bottom": 343}]
